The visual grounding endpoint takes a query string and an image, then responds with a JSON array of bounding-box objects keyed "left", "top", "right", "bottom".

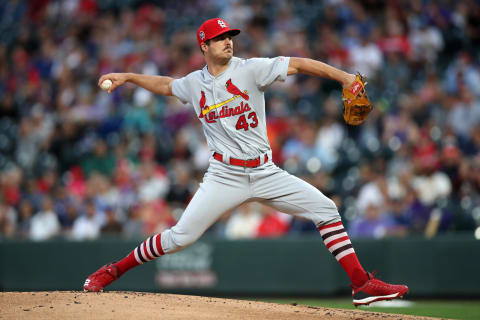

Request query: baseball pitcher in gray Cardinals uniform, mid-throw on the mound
[{"left": 83, "top": 18, "right": 408, "bottom": 306}]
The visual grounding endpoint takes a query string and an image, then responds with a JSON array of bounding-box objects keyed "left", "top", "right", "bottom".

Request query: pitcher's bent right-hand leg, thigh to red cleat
[{"left": 252, "top": 165, "right": 408, "bottom": 306}]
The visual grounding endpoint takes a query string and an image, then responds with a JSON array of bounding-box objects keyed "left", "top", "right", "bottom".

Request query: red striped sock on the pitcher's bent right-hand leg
[{"left": 318, "top": 221, "right": 368, "bottom": 287}]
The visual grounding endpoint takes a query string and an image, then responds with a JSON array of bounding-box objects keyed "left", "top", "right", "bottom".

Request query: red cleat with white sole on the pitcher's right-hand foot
[{"left": 351, "top": 273, "right": 408, "bottom": 307}]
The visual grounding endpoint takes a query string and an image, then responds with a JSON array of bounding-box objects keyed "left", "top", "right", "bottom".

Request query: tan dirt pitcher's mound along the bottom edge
[{"left": 0, "top": 291, "right": 442, "bottom": 320}]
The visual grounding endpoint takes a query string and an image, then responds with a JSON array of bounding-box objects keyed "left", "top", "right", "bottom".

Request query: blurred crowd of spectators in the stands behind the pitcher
[{"left": 0, "top": 0, "right": 480, "bottom": 240}]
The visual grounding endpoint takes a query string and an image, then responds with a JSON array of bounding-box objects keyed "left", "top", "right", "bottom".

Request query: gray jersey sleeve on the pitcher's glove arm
[{"left": 252, "top": 57, "right": 290, "bottom": 90}]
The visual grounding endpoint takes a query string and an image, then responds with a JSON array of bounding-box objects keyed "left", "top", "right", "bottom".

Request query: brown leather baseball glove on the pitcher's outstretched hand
[{"left": 342, "top": 74, "right": 373, "bottom": 126}]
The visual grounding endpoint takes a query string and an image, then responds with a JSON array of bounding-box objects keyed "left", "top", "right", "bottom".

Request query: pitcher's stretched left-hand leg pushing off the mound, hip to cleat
[{"left": 83, "top": 172, "right": 250, "bottom": 291}]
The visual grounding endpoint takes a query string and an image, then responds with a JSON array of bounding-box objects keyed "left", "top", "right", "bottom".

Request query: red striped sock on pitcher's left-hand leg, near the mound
[{"left": 113, "top": 233, "right": 165, "bottom": 275}]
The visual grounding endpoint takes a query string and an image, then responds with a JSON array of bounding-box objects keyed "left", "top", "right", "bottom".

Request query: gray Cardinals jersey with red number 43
[{"left": 172, "top": 57, "right": 290, "bottom": 159}]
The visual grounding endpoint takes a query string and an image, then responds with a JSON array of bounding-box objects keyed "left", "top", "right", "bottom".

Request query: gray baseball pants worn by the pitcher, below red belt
[{"left": 161, "top": 157, "right": 341, "bottom": 254}]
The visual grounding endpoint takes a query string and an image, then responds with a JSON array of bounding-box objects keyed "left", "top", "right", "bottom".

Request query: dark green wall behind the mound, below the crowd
[{"left": 0, "top": 235, "right": 480, "bottom": 297}]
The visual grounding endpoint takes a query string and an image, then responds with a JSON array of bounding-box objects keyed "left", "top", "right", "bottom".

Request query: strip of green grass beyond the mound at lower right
[{"left": 259, "top": 298, "right": 480, "bottom": 320}]
